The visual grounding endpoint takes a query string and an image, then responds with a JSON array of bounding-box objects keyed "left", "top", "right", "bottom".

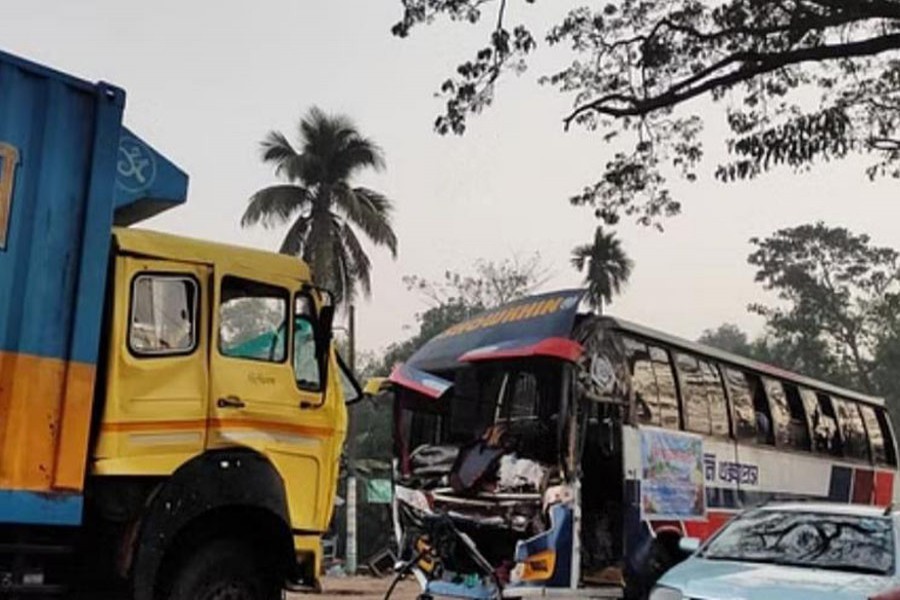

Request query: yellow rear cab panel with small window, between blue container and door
[{"left": 94, "top": 257, "right": 210, "bottom": 475}]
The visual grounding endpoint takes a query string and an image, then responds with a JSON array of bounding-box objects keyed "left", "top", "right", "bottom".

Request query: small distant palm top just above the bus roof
[{"left": 572, "top": 227, "right": 634, "bottom": 312}]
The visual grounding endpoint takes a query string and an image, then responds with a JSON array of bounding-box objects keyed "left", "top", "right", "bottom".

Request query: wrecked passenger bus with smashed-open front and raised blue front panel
[{"left": 389, "top": 290, "right": 897, "bottom": 598}]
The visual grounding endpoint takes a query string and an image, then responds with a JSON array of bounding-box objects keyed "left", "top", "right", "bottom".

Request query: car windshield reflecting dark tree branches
[{"left": 702, "top": 510, "right": 894, "bottom": 574}]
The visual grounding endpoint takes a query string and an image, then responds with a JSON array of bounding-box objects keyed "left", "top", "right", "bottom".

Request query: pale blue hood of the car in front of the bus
[{"left": 659, "top": 557, "right": 896, "bottom": 600}]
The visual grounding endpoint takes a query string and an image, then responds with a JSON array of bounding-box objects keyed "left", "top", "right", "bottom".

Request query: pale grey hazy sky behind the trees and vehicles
[{"left": 0, "top": 0, "right": 900, "bottom": 351}]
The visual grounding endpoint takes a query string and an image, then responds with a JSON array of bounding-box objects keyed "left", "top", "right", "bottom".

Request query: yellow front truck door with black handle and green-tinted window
[{"left": 207, "top": 269, "right": 346, "bottom": 531}]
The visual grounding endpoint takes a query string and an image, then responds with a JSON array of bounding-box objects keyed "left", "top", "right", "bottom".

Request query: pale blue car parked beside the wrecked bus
[{"left": 649, "top": 502, "right": 900, "bottom": 600}]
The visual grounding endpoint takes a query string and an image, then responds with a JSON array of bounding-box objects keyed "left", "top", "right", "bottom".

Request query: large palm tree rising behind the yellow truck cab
[{"left": 241, "top": 107, "right": 397, "bottom": 303}]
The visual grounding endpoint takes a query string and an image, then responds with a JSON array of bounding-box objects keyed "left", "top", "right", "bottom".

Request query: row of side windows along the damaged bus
[{"left": 622, "top": 336, "right": 897, "bottom": 466}]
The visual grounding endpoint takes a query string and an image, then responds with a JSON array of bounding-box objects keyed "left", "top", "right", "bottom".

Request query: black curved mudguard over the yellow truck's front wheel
[{"left": 131, "top": 448, "right": 294, "bottom": 600}]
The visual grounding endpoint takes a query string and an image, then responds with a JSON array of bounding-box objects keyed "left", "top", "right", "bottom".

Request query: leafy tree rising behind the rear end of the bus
[{"left": 748, "top": 223, "right": 900, "bottom": 393}]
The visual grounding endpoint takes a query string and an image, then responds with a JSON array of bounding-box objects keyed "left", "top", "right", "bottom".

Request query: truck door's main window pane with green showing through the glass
[{"left": 219, "top": 276, "right": 288, "bottom": 362}]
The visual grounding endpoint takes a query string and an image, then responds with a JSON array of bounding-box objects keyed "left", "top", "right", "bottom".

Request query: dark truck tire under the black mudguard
[{"left": 163, "top": 539, "right": 282, "bottom": 600}]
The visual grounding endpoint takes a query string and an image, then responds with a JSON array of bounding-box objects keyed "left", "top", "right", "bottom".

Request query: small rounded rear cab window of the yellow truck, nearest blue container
[{"left": 128, "top": 274, "right": 197, "bottom": 356}]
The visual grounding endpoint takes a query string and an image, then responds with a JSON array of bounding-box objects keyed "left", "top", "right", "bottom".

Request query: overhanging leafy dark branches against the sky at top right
[{"left": 392, "top": 0, "right": 900, "bottom": 226}]
